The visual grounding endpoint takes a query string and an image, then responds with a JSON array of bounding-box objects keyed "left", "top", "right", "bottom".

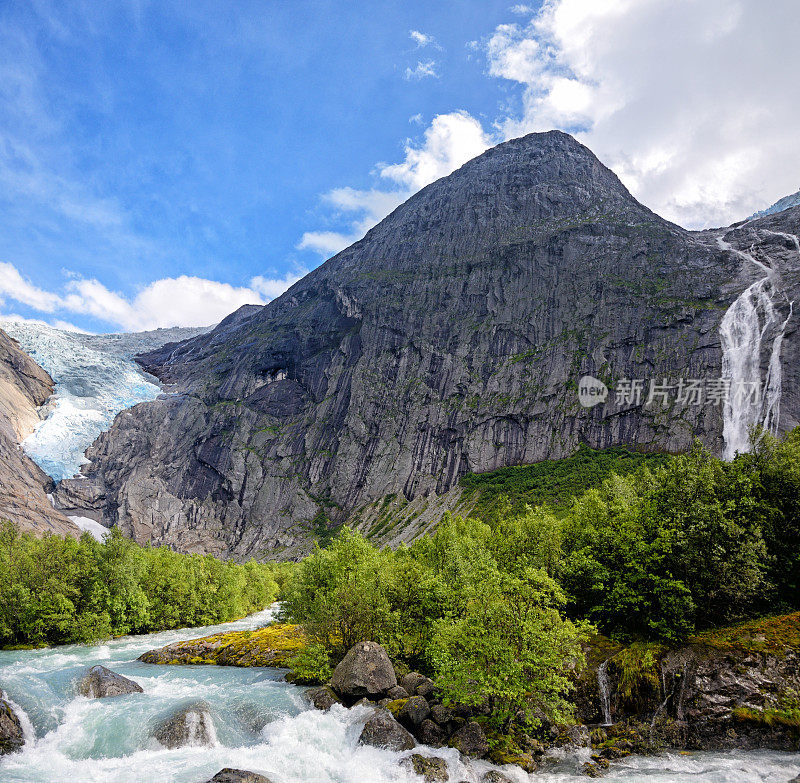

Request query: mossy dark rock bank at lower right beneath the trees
[{"left": 577, "top": 614, "right": 800, "bottom": 758}]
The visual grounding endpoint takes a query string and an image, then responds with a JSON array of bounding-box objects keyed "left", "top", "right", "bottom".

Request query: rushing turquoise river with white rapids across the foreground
[{"left": 0, "top": 610, "right": 800, "bottom": 783}]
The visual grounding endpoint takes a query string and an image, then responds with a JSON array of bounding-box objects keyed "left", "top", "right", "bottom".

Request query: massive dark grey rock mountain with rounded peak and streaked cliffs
[{"left": 58, "top": 132, "right": 800, "bottom": 557}]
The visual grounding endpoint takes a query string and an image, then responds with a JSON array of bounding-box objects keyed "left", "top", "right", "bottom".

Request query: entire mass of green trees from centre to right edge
[{"left": 285, "top": 430, "right": 800, "bottom": 723}]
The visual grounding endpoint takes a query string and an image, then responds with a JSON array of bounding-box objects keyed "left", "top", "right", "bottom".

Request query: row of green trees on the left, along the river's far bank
[{"left": 0, "top": 522, "right": 285, "bottom": 647}]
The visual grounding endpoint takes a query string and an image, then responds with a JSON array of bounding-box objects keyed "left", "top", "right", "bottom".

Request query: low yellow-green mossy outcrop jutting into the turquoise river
[{"left": 138, "top": 623, "right": 306, "bottom": 668}]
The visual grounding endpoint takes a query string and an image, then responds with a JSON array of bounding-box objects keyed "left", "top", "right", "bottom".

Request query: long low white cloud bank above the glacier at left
[{"left": 0, "top": 263, "right": 304, "bottom": 331}]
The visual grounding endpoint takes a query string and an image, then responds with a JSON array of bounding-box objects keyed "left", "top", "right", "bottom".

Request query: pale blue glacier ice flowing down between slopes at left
[{"left": 0, "top": 319, "right": 207, "bottom": 482}]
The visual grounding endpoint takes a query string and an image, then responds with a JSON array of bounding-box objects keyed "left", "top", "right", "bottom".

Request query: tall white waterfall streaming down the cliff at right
[{"left": 717, "top": 232, "right": 800, "bottom": 460}]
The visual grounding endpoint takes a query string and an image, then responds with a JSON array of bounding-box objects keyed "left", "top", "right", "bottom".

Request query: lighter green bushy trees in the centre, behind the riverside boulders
[{"left": 284, "top": 516, "right": 588, "bottom": 727}]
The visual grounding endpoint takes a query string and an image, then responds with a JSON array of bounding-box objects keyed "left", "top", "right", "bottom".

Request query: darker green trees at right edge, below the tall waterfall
[{"left": 556, "top": 431, "right": 800, "bottom": 641}]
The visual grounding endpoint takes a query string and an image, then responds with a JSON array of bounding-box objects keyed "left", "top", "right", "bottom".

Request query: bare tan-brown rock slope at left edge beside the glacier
[{"left": 0, "top": 330, "right": 79, "bottom": 535}]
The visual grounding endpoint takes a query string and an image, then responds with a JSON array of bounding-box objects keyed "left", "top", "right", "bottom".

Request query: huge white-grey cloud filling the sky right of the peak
[{"left": 485, "top": 0, "right": 800, "bottom": 227}]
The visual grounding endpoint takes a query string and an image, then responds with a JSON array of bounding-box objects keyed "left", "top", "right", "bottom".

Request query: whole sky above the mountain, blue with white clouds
[{"left": 0, "top": 0, "right": 800, "bottom": 331}]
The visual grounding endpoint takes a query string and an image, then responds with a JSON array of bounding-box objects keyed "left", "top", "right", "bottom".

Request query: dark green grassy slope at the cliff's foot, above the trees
[{"left": 459, "top": 444, "right": 669, "bottom": 521}]
